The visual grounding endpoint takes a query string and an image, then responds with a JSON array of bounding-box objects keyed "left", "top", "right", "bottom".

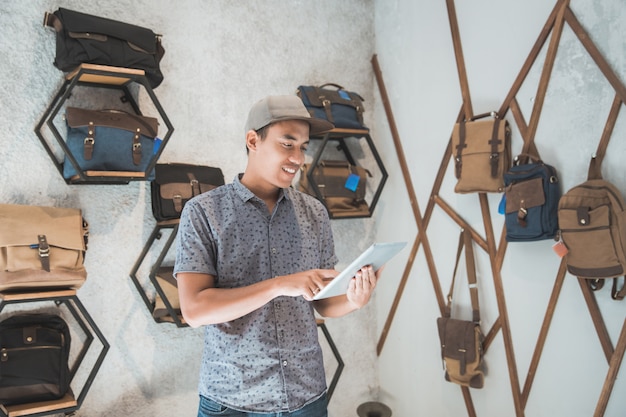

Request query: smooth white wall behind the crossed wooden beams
[{"left": 374, "top": 0, "right": 626, "bottom": 417}]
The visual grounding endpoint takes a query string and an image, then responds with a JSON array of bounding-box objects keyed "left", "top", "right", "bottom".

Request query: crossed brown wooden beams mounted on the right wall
[{"left": 371, "top": 0, "right": 626, "bottom": 417}]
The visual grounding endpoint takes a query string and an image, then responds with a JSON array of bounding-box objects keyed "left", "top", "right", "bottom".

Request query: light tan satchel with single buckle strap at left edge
[{"left": 0, "top": 204, "right": 88, "bottom": 291}]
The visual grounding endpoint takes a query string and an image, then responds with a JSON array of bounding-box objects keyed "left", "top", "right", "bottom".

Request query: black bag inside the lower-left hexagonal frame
[{"left": 0, "top": 313, "right": 70, "bottom": 405}]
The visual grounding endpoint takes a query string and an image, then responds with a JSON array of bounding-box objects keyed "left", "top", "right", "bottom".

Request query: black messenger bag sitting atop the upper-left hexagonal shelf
[{"left": 44, "top": 8, "right": 165, "bottom": 88}]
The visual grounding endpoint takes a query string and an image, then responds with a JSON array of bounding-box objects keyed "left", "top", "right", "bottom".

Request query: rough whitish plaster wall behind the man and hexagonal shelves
[{"left": 0, "top": 0, "right": 378, "bottom": 417}]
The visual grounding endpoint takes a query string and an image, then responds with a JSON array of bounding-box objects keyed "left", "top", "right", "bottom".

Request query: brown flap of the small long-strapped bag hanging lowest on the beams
[{"left": 437, "top": 317, "right": 480, "bottom": 362}]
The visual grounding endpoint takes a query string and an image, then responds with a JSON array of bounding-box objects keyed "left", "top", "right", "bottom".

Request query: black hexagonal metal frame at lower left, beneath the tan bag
[{"left": 0, "top": 290, "right": 110, "bottom": 417}]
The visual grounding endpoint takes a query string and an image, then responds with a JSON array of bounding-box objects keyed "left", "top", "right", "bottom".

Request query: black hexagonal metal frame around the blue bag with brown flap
[{"left": 35, "top": 65, "right": 174, "bottom": 184}]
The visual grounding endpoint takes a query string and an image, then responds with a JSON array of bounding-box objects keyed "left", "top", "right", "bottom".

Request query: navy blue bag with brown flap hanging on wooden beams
[{"left": 504, "top": 154, "right": 561, "bottom": 242}]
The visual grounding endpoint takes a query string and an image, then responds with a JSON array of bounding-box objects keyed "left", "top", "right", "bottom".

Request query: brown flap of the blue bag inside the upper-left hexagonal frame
[{"left": 65, "top": 107, "right": 159, "bottom": 139}]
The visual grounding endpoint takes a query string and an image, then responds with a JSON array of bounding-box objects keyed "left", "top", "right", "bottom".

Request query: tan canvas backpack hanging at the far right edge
[{"left": 558, "top": 178, "right": 626, "bottom": 300}]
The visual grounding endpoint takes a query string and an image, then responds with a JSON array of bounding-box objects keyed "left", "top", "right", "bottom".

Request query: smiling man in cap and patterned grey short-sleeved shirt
[{"left": 175, "top": 95, "right": 380, "bottom": 417}]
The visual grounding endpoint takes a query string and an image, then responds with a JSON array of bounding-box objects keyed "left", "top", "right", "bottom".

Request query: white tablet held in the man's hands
[{"left": 313, "top": 242, "right": 406, "bottom": 300}]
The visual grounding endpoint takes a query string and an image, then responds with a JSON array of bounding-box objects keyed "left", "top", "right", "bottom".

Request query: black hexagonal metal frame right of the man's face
[{"left": 306, "top": 129, "right": 388, "bottom": 219}]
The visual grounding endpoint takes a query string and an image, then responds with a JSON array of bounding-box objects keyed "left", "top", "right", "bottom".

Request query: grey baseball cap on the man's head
[{"left": 246, "top": 95, "right": 335, "bottom": 135}]
